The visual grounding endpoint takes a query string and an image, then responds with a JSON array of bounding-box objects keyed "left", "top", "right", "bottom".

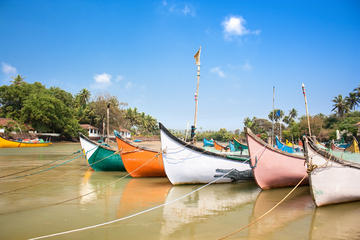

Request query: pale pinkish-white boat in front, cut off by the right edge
[{"left": 304, "top": 137, "right": 360, "bottom": 207}]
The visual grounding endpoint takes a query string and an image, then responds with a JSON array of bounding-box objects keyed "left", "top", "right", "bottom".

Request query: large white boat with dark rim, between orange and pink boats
[{"left": 159, "top": 123, "right": 253, "bottom": 185}]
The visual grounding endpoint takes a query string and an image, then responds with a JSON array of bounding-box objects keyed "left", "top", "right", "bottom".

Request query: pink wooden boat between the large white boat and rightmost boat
[{"left": 245, "top": 128, "right": 309, "bottom": 190}]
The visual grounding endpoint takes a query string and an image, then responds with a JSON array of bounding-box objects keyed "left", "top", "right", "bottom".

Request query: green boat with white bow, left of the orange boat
[{"left": 79, "top": 134, "right": 125, "bottom": 171}]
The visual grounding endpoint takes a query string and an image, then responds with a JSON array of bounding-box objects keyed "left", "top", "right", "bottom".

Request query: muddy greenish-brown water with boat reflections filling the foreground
[{"left": 0, "top": 144, "right": 360, "bottom": 240}]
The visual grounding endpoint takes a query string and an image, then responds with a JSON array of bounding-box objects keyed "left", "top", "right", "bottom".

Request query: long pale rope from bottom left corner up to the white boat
[{"left": 30, "top": 169, "right": 234, "bottom": 240}]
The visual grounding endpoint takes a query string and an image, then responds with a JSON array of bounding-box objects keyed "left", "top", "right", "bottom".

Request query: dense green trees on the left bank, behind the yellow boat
[{"left": 0, "top": 75, "right": 158, "bottom": 139}]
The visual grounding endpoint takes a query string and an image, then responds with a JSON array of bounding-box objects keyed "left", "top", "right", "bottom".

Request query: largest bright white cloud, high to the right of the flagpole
[{"left": 222, "top": 16, "right": 260, "bottom": 40}]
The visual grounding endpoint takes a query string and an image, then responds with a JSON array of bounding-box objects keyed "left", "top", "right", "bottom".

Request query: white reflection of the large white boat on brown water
[{"left": 161, "top": 183, "right": 260, "bottom": 238}]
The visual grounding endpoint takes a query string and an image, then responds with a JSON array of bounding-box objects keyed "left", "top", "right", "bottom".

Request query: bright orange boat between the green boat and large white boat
[{"left": 114, "top": 131, "right": 166, "bottom": 177}]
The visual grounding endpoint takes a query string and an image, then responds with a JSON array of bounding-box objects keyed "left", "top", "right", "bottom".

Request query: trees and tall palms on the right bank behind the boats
[{"left": 244, "top": 86, "right": 360, "bottom": 141}]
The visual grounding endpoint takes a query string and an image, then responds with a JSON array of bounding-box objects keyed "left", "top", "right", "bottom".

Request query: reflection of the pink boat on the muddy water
[{"left": 248, "top": 187, "right": 315, "bottom": 239}]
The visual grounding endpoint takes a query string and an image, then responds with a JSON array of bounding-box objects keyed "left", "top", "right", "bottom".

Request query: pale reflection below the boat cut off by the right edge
[{"left": 309, "top": 202, "right": 360, "bottom": 240}]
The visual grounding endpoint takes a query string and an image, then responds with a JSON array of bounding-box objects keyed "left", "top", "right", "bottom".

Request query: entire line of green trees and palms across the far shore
[{"left": 0, "top": 75, "right": 360, "bottom": 142}]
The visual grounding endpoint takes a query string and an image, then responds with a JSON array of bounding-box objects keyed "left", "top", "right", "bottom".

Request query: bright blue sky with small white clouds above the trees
[{"left": 0, "top": 0, "right": 360, "bottom": 130}]
